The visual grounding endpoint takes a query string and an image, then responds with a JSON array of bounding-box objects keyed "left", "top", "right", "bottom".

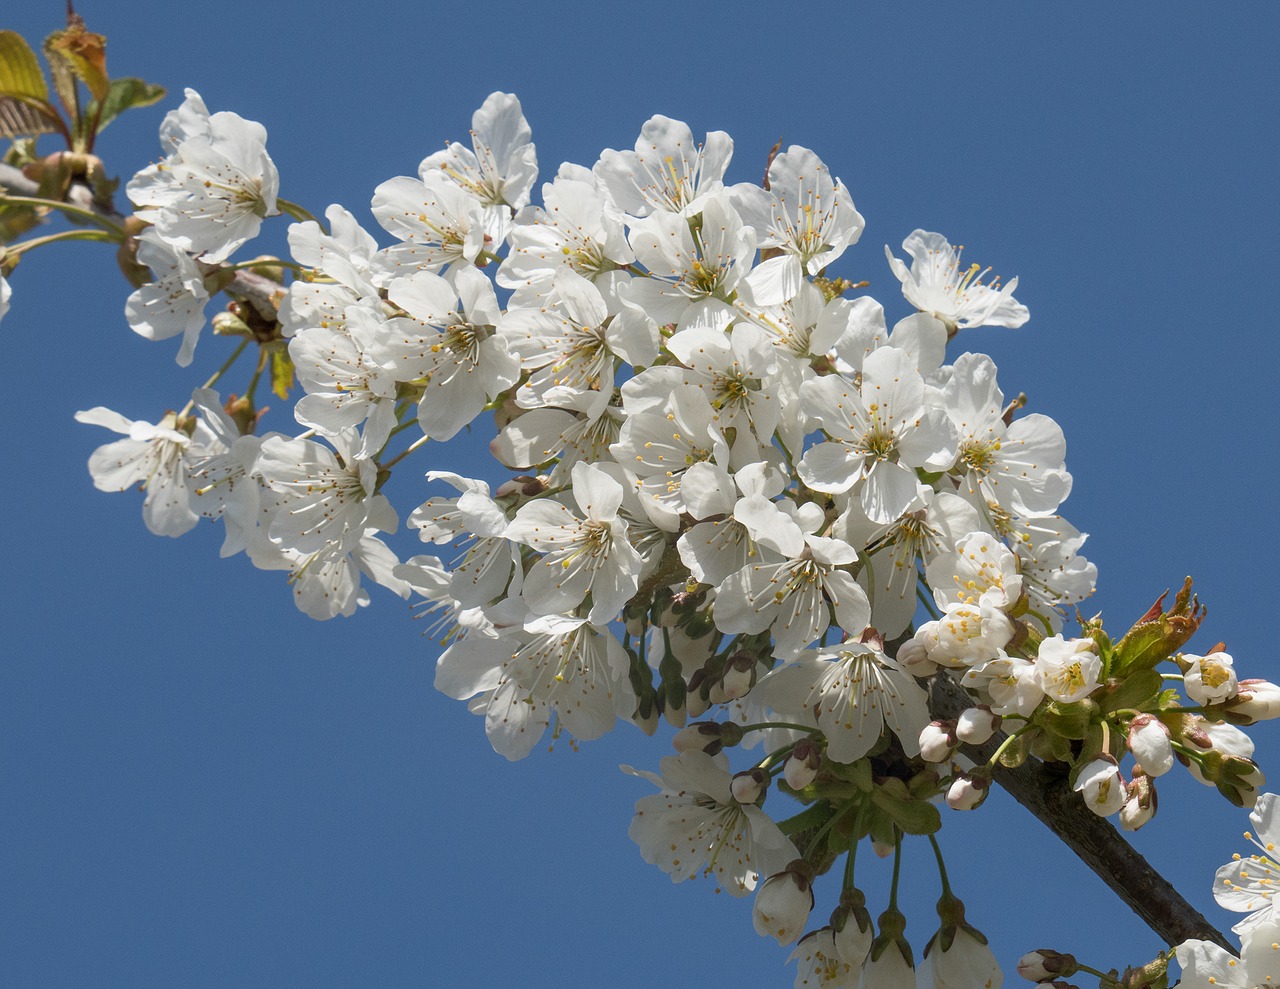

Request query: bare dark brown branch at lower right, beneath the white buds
[{"left": 929, "top": 670, "right": 1236, "bottom": 954}]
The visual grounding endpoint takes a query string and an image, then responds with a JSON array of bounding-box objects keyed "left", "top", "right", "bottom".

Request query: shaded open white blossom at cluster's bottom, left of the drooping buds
[{"left": 622, "top": 751, "right": 799, "bottom": 897}]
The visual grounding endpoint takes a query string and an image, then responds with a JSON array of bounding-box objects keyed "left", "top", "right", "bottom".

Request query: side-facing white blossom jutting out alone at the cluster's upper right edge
[{"left": 884, "top": 230, "right": 1029, "bottom": 329}]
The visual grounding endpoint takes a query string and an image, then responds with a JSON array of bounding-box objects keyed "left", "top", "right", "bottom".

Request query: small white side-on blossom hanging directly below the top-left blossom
[{"left": 124, "top": 228, "right": 209, "bottom": 367}]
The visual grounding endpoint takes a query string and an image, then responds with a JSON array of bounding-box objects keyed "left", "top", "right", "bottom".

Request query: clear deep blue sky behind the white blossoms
[{"left": 0, "top": 0, "right": 1280, "bottom": 989}]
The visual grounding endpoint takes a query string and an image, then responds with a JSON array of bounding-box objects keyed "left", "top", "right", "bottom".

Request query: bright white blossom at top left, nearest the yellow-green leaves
[{"left": 128, "top": 90, "right": 279, "bottom": 264}]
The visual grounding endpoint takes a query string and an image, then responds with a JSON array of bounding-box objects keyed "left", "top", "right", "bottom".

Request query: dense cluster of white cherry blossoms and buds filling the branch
[{"left": 47, "top": 91, "right": 1280, "bottom": 989}]
